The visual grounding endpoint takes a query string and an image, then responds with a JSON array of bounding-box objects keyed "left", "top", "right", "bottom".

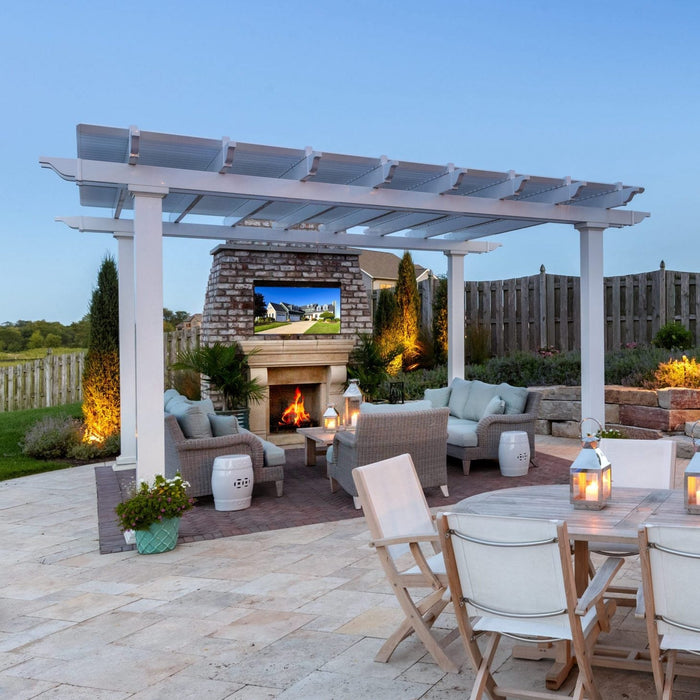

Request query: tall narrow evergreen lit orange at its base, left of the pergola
[{"left": 83, "top": 255, "right": 120, "bottom": 442}]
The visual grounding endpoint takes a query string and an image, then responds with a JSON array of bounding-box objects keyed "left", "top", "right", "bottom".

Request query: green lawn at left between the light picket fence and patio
[{"left": 0, "top": 403, "right": 82, "bottom": 481}]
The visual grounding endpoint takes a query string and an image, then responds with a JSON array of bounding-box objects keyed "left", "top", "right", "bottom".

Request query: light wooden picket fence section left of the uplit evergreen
[{"left": 0, "top": 352, "right": 85, "bottom": 412}]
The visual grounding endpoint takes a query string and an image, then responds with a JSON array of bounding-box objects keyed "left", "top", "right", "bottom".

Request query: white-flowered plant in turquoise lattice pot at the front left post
[{"left": 115, "top": 472, "right": 194, "bottom": 554}]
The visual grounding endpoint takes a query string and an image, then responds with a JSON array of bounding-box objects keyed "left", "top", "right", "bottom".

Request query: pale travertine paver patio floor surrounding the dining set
[{"left": 0, "top": 437, "right": 700, "bottom": 700}]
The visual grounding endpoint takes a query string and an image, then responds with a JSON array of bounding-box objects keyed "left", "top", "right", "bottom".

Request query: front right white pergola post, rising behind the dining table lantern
[{"left": 576, "top": 223, "right": 605, "bottom": 427}]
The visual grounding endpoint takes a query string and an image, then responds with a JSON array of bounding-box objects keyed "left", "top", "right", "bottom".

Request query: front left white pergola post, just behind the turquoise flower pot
[{"left": 129, "top": 185, "right": 168, "bottom": 481}]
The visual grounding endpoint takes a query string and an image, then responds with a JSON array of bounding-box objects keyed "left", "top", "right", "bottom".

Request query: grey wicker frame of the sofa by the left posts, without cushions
[{"left": 165, "top": 415, "right": 284, "bottom": 496}]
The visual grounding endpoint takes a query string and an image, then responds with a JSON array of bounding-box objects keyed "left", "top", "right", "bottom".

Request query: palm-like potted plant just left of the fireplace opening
[{"left": 172, "top": 341, "right": 265, "bottom": 428}]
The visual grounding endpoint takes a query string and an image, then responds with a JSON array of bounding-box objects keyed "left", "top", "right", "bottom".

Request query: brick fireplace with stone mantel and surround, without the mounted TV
[{"left": 202, "top": 242, "right": 372, "bottom": 445}]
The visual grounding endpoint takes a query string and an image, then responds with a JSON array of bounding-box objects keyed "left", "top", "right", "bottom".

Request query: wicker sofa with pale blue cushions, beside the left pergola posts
[{"left": 165, "top": 390, "right": 285, "bottom": 496}]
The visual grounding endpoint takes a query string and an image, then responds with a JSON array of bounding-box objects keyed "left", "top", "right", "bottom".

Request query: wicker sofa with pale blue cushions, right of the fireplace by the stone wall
[{"left": 424, "top": 378, "right": 542, "bottom": 474}]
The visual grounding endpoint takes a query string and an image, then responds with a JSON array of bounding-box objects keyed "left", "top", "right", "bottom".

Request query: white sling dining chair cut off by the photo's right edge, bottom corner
[{"left": 639, "top": 525, "right": 700, "bottom": 700}]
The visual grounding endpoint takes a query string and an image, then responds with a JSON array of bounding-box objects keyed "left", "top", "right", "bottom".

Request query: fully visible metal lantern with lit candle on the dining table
[{"left": 569, "top": 418, "right": 612, "bottom": 510}]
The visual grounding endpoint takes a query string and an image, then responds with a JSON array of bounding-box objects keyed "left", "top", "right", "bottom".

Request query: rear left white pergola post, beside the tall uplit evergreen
[{"left": 114, "top": 235, "right": 136, "bottom": 469}]
